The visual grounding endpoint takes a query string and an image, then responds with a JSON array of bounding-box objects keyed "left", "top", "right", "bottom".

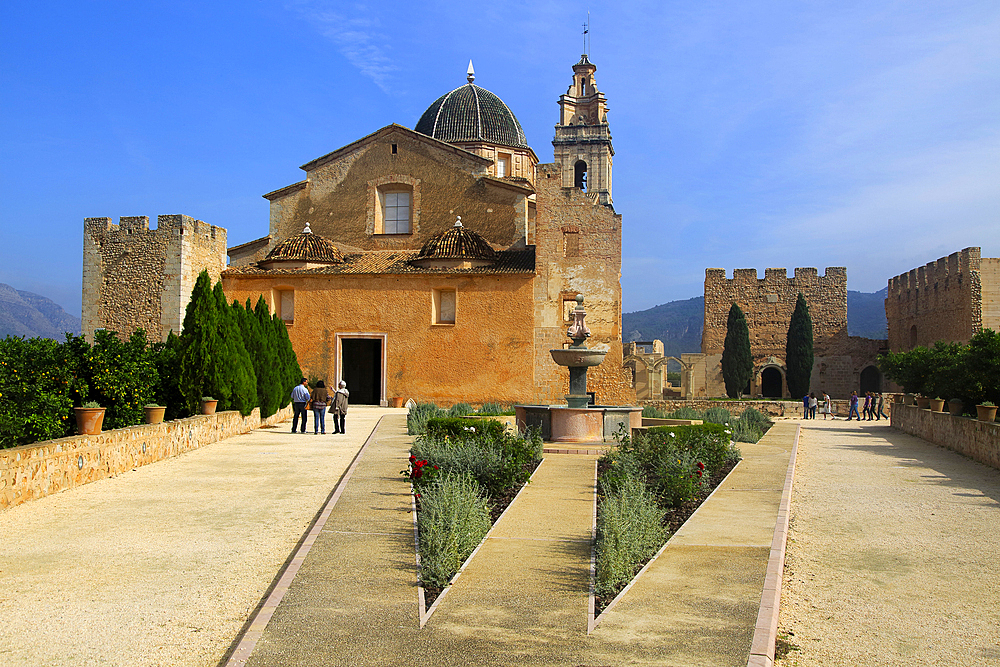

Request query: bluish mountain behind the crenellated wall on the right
[{"left": 622, "top": 287, "right": 888, "bottom": 356}]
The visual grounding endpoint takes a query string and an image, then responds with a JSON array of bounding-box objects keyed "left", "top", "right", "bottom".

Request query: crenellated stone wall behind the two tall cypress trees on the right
[{"left": 701, "top": 266, "right": 847, "bottom": 360}]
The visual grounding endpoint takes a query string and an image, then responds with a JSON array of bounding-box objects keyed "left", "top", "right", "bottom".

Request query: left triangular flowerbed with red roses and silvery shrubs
[{"left": 403, "top": 418, "right": 542, "bottom": 605}]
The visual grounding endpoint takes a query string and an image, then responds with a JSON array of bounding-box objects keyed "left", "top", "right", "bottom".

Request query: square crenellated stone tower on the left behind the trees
[{"left": 82, "top": 215, "right": 226, "bottom": 341}]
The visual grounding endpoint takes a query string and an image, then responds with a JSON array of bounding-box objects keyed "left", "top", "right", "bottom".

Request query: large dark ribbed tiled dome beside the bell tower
[{"left": 416, "top": 83, "right": 528, "bottom": 148}]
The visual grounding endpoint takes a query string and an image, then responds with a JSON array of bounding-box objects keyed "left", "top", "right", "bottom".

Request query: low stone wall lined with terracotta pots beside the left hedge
[{"left": 0, "top": 405, "right": 292, "bottom": 509}]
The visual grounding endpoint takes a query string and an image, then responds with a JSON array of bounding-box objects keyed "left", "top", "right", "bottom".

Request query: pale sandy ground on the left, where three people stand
[{"left": 0, "top": 407, "right": 405, "bottom": 667}]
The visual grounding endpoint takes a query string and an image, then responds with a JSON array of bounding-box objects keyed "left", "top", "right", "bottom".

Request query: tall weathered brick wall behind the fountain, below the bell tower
[{"left": 534, "top": 164, "right": 636, "bottom": 405}]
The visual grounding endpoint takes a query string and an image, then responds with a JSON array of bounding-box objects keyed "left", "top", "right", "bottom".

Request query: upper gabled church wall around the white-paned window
[{"left": 265, "top": 126, "right": 531, "bottom": 250}]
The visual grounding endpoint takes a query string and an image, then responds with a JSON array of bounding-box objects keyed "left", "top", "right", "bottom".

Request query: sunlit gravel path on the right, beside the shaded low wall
[{"left": 775, "top": 420, "right": 1000, "bottom": 667}]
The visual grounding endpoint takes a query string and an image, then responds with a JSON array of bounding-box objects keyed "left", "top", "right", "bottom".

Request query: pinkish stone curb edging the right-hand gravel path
[{"left": 747, "top": 424, "right": 802, "bottom": 667}]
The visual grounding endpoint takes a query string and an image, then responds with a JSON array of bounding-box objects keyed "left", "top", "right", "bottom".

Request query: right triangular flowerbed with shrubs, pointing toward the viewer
[{"left": 594, "top": 424, "right": 752, "bottom": 613}]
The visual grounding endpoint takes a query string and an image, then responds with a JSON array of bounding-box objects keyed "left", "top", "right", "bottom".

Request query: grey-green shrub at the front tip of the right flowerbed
[{"left": 594, "top": 474, "right": 667, "bottom": 597}]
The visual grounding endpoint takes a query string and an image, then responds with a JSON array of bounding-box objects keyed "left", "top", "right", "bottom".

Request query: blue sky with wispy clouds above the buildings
[{"left": 0, "top": 0, "right": 1000, "bottom": 314}]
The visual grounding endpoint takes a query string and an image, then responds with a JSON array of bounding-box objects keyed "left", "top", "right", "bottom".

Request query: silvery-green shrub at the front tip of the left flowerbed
[{"left": 417, "top": 473, "right": 491, "bottom": 588}]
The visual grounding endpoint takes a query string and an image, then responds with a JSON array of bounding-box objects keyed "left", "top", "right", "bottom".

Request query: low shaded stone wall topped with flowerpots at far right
[{"left": 890, "top": 403, "right": 1000, "bottom": 468}]
